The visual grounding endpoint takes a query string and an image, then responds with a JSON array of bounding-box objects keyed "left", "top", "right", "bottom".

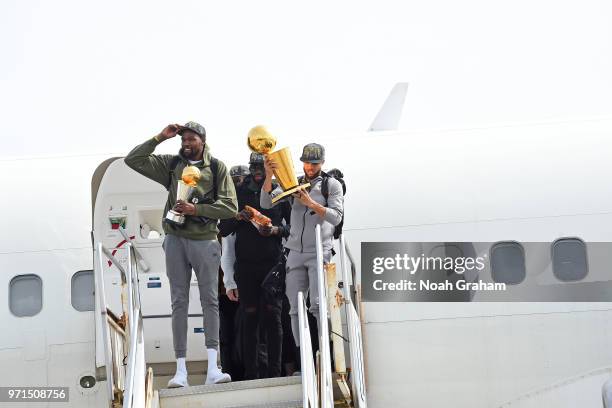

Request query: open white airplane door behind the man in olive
[{"left": 92, "top": 158, "right": 206, "bottom": 363}]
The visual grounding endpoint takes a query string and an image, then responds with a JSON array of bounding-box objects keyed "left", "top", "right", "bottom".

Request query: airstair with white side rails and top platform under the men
[{"left": 94, "top": 226, "right": 367, "bottom": 408}]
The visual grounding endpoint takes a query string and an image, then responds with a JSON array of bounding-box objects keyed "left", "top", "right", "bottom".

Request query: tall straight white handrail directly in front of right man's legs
[{"left": 315, "top": 224, "right": 334, "bottom": 408}]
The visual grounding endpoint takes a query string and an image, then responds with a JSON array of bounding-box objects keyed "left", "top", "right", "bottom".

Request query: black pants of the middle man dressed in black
[{"left": 235, "top": 262, "right": 283, "bottom": 380}]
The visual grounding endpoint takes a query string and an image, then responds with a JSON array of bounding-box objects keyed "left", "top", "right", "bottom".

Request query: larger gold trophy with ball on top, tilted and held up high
[{"left": 247, "top": 125, "right": 310, "bottom": 203}]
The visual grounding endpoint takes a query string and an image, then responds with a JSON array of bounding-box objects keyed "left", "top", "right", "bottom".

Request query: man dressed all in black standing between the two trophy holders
[{"left": 219, "top": 153, "right": 291, "bottom": 380}]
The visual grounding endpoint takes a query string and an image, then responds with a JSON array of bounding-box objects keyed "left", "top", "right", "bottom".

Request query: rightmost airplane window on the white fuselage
[{"left": 552, "top": 238, "right": 589, "bottom": 282}]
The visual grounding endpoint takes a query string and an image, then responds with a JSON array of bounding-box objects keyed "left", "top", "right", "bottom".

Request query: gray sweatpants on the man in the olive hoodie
[{"left": 163, "top": 234, "right": 221, "bottom": 358}]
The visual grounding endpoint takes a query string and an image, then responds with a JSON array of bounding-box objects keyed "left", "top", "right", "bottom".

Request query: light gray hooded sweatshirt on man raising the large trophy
[{"left": 260, "top": 176, "right": 344, "bottom": 252}]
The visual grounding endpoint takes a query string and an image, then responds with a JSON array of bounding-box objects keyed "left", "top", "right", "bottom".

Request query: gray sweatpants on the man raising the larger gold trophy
[{"left": 286, "top": 250, "right": 331, "bottom": 347}]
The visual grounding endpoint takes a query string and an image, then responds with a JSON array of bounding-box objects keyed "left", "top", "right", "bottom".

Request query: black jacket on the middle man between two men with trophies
[{"left": 219, "top": 176, "right": 291, "bottom": 263}]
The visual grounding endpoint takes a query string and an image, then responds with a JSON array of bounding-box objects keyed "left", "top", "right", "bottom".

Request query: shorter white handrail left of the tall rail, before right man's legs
[{"left": 298, "top": 292, "right": 319, "bottom": 408}]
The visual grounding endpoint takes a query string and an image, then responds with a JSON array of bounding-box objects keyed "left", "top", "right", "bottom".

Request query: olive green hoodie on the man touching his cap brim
[{"left": 125, "top": 138, "right": 238, "bottom": 240}]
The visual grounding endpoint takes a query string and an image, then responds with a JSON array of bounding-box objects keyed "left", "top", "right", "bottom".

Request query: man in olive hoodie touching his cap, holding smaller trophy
[{"left": 125, "top": 122, "right": 238, "bottom": 387}]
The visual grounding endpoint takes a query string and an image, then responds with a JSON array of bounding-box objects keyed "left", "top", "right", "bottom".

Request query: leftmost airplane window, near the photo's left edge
[{"left": 9, "top": 275, "right": 42, "bottom": 317}]
